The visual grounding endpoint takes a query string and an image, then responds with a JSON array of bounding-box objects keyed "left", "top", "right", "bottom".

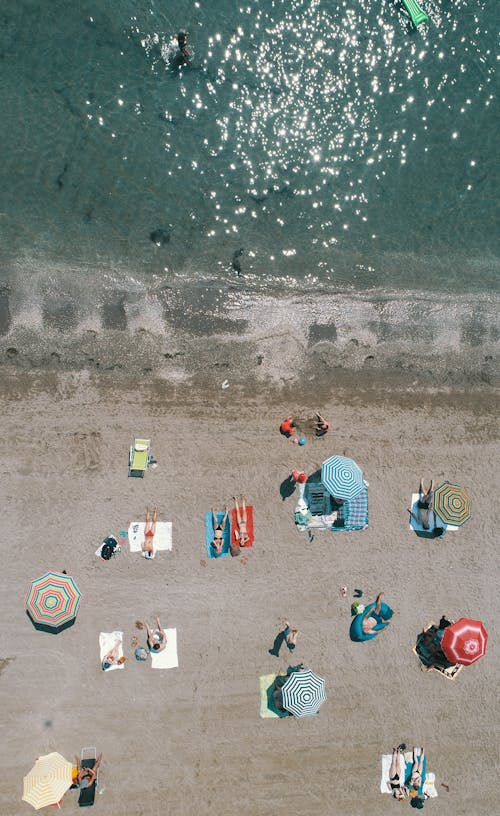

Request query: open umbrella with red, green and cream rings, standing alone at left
[{"left": 26, "top": 572, "right": 80, "bottom": 630}]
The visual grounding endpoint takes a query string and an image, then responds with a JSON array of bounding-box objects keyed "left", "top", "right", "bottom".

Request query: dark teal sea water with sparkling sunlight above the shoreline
[{"left": 0, "top": 0, "right": 500, "bottom": 318}]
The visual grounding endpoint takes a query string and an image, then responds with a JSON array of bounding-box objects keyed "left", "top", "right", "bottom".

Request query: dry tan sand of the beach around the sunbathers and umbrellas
[{"left": 0, "top": 366, "right": 500, "bottom": 816}]
